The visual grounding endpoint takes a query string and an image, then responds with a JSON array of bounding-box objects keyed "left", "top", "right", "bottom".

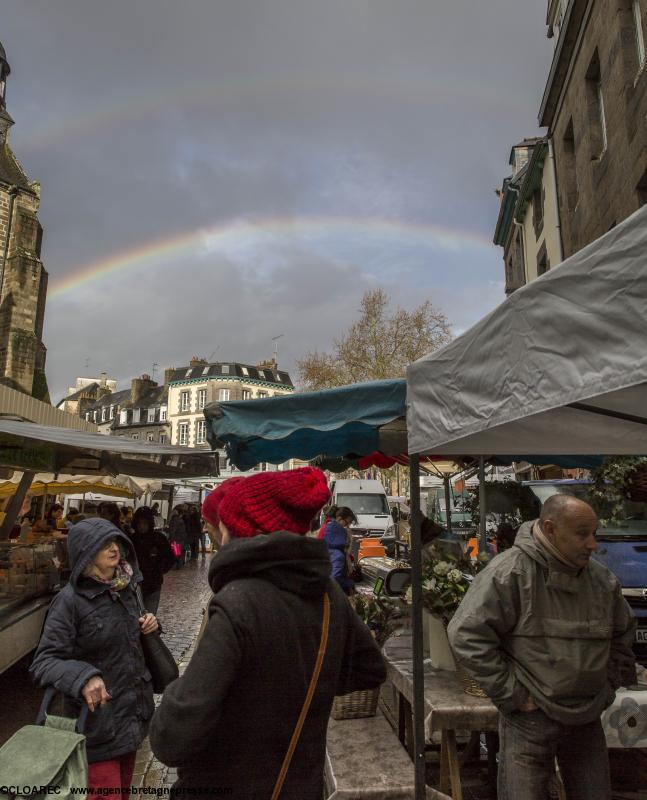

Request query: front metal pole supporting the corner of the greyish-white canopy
[{"left": 410, "top": 455, "right": 426, "bottom": 800}]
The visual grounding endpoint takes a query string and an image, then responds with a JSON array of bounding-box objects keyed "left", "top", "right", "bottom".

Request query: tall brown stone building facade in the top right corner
[{"left": 539, "top": 0, "right": 647, "bottom": 257}]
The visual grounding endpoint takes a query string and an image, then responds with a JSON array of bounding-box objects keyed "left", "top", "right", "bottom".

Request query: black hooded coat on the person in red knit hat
[{"left": 150, "top": 532, "right": 386, "bottom": 800}]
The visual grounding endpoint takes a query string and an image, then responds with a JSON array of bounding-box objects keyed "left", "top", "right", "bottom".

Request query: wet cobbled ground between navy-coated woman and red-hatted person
[{"left": 133, "top": 555, "right": 211, "bottom": 789}]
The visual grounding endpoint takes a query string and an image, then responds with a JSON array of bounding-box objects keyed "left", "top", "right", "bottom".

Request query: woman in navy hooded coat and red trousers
[{"left": 30, "top": 517, "right": 158, "bottom": 798}]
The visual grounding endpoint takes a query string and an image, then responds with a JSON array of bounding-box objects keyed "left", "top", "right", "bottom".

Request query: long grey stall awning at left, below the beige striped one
[{"left": 0, "top": 419, "right": 218, "bottom": 479}]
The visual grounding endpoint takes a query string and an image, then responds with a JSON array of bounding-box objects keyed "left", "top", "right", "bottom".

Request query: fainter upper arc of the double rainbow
[{"left": 17, "top": 74, "right": 525, "bottom": 153}]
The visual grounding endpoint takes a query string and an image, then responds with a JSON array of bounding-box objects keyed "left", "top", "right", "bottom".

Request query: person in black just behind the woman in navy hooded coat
[{"left": 130, "top": 506, "right": 175, "bottom": 614}]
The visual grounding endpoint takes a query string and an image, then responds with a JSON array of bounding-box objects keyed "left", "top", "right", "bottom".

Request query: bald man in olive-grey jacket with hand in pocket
[{"left": 448, "top": 494, "right": 636, "bottom": 800}]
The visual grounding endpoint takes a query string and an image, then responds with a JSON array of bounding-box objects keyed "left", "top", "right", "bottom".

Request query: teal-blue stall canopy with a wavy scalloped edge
[{"left": 205, "top": 379, "right": 406, "bottom": 470}]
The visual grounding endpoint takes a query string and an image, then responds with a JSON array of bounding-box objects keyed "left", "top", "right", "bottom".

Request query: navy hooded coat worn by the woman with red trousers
[{"left": 30, "top": 518, "right": 154, "bottom": 763}]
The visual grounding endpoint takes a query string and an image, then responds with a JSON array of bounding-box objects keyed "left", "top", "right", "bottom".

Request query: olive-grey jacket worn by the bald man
[{"left": 448, "top": 522, "right": 635, "bottom": 725}]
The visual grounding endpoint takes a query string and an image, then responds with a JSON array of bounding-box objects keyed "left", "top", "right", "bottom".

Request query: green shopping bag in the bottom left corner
[{"left": 0, "top": 687, "right": 88, "bottom": 800}]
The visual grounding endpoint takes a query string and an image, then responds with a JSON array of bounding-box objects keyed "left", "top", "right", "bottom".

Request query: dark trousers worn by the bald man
[{"left": 497, "top": 711, "right": 611, "bottom": 800}]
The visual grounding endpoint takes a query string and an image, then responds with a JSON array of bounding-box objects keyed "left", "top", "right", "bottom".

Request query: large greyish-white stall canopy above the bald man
[{"left": 407, "top": 206, "right": 647, "bottom": 455}]
